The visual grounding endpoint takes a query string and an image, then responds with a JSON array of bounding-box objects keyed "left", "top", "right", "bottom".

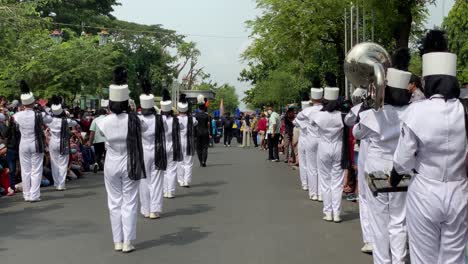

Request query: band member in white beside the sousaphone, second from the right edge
[{"left": 353, "top": 49, "right": 411, "bottom": 264}]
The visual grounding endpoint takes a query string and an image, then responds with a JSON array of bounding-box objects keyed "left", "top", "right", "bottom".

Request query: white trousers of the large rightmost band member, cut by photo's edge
[{"left": 407, "top": 175, "right": 468, "bottom": 264}]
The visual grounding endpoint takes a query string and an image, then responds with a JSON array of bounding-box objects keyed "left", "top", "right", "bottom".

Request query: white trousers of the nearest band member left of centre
[{"left": 104, "top": 159, "right": 139, "bottom": 243}]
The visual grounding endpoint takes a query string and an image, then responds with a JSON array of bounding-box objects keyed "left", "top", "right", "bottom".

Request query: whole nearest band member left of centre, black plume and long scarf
[{"left": 97, "top": 67, "right": 146, "bottom": 253}]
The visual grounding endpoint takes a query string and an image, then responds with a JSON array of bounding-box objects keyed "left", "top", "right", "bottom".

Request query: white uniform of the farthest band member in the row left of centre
[{"left": 177, "top": 115, "right": 198, "bottom": 186}]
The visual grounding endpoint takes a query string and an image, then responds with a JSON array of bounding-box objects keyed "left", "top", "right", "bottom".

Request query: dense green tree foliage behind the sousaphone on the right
[{"left": 243, "top": 0, "right": 434, "bottom": 107}]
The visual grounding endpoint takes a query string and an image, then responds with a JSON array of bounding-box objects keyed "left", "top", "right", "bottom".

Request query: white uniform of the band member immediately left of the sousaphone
[{"left": 312, "top": 111, "right": 344, "bottom": 216}]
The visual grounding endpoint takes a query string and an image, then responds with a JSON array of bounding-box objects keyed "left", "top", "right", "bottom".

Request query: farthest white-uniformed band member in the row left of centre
[{"left": 177, "top": 94, "right": 198, "bottom": 188}]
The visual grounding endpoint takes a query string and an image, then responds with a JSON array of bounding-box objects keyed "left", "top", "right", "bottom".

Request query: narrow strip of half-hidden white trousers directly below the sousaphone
[{"left": 357, "top": 140, "right": 373, "bottom": 243}]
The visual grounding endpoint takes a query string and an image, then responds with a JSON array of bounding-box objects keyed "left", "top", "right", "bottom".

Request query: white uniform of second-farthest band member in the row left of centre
[{"left": 163, "top": 115, "right": 178, "bottom": 195}]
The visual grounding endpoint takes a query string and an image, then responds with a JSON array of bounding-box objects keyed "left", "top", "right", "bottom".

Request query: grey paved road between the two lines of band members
[{"left": 0, "top": 147, "right": 372, "bottom": 264}]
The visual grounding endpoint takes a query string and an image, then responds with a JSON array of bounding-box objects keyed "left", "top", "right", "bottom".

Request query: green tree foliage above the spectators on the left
[{"left": 0, "top": 0, "right": 227, "bottom": 104}]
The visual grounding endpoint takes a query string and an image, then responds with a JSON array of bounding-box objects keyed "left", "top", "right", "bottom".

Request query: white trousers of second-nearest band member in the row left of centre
[{"left": 140, "top": 150, "right": 164, "bottom": 215}]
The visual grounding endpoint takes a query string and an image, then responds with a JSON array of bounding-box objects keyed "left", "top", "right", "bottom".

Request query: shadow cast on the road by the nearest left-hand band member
[{"left": 137, "top": 227, "right": 211, "bottom": 250}]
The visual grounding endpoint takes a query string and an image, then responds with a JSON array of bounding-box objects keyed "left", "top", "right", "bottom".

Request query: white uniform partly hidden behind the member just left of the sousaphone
[{"left": 294, "top": 104, "right": 322, "bottom": 198}]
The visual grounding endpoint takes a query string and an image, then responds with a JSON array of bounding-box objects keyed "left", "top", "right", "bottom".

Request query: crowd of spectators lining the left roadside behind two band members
[{"left": 0, "top": 96, "right": 104, "bottom": 196}]
